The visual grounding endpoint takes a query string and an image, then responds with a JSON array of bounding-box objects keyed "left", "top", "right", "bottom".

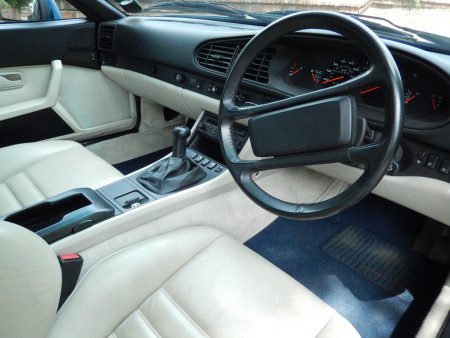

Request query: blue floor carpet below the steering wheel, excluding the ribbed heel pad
[{"left": 245, "top": 195, "right": 447, "bottom": 338}]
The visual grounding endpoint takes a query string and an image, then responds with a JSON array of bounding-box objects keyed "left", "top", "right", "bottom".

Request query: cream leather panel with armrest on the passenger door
[{"left": 0, "top": 60, "right": 136, "bottom": 140}]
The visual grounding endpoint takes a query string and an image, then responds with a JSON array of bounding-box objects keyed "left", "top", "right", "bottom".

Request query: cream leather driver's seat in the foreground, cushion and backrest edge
[{"left": 0, "top": 223, "right": 359, "bottom": 338}]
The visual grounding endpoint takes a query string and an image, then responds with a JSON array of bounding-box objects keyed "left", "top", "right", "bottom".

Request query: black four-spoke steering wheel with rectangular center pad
[{"left": 219, "top": 12, "right": 404, "bottom": 220}]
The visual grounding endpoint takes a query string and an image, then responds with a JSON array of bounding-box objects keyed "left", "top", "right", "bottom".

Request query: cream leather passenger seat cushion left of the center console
[{"left": 0, "top": 141, "right": 122, "bottom": 215}]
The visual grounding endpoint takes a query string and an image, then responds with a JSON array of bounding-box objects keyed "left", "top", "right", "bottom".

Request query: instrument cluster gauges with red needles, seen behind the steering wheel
[{"left": 284, "top": 53, "right": 449, "bottom": 120}]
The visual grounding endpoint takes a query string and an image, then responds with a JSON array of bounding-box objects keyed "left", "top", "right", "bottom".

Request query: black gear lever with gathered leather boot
[{"left": 137, "top": 126, "right": 206, "bottom": 194}]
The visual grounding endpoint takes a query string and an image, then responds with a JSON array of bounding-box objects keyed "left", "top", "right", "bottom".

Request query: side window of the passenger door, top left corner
[{"left": 0, "top": 0, "right": 85, "bottom": 23}]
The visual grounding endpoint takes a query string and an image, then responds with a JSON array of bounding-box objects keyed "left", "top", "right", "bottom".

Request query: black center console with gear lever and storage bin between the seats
[{"left": 0, "top": 113, "right": 248, "bottom": 243}]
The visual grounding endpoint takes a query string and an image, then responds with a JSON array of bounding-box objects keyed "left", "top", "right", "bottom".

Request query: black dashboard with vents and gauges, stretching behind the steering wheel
[{"left": 98, "top": 18, "right": 450, "bottom": 182}]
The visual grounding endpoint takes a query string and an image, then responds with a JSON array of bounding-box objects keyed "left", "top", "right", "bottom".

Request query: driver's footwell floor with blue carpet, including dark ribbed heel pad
[{"left": 245, "top": 195, "right": 448, "bottom": 337}]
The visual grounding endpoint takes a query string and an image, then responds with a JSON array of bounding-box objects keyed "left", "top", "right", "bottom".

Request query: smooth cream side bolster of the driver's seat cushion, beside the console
[{"left": 50, "top": 227, "right": 222, "bottom": 338}]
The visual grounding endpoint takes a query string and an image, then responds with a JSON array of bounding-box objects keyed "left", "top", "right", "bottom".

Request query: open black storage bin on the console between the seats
[{"left": 3, "top": 188, "right": 115, "bottom": 243}]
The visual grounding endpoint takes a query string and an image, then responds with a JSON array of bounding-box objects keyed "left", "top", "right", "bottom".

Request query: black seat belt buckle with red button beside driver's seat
[{"left": 58, "top": 253, "right": 83, "bottom": 309}]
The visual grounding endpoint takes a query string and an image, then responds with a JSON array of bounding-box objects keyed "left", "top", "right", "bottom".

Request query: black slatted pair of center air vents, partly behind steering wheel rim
[{"left": 196, "top": 40, "right": 276, "bottom": 84}]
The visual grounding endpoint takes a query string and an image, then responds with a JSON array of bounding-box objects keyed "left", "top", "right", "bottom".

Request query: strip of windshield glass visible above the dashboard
[{"left": 111, "top": 0, "right": 450, "bottom": 37}]
